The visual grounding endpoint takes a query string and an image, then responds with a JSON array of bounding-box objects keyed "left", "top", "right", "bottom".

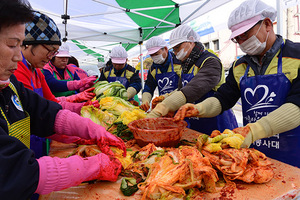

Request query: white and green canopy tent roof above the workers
[{"left": 29, "top": 0, "right": 230, "bottom": 64}]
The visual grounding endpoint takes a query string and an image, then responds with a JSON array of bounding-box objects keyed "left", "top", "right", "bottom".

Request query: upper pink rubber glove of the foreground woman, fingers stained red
[{"left": 54, "top": 109, "right": 126, "bottom": 156}]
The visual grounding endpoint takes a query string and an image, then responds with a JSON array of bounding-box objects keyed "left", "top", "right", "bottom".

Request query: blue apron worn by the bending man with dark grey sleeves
[{"left": 181, "top": 67, "right": 238, "bottom": 135}]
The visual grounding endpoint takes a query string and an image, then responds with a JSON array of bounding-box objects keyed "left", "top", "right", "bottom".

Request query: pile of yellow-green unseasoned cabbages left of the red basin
[{"left": 81, "top": 81, "right": 146, "bottom": 141}]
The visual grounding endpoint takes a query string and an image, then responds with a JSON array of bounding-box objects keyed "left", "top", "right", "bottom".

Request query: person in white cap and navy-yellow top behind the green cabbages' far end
[{"left": 99, "top": 46, "right": 142, "bottom": 100}]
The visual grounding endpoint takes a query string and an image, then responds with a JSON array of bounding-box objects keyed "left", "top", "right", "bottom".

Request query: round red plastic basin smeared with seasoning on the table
[{"left": 128, "top": 117, "right": 187, "bottom": 147}]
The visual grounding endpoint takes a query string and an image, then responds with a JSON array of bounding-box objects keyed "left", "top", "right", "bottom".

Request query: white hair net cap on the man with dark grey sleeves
[{"left": 169, "top": 24, "right": 200, "bottom": 48}]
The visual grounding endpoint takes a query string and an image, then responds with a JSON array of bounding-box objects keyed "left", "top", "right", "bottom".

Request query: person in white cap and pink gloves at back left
[{"left": 43, "top": 43, "right": 97, "bottom": 97}]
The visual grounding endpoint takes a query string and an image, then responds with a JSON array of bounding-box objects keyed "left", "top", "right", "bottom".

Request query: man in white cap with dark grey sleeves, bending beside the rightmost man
[{"left": 147, "top": 25, "right": 237, "bottom": 134}]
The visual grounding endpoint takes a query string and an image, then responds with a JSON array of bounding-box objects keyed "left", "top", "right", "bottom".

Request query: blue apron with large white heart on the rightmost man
[{"left": 240, "top": 43, "right": 300, "bottom": 167}]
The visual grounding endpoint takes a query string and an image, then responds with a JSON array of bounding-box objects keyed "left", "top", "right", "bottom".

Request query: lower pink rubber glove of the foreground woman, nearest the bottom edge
[{"left": 35, "top": 153, "right": 122, "bottom": 194}]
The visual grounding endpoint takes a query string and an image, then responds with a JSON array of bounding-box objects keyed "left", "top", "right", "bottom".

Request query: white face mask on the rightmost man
[{"left": 240, "top": 23, "right": 269, "bottom": 56}]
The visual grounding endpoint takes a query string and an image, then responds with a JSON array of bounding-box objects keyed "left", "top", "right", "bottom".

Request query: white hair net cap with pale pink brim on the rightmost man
[{"left": 228, "top": 0, "right": 277, "bottom": 39}]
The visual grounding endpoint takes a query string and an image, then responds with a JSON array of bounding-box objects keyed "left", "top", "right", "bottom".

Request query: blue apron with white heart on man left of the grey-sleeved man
[{"left": 155, "top": 53, "right": 179, "bottom": 95}]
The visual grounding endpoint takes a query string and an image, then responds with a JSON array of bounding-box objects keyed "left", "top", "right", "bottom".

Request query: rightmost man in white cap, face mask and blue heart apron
[{"left": 175, "top": 0, "right": 300, "bottom": 167}]
